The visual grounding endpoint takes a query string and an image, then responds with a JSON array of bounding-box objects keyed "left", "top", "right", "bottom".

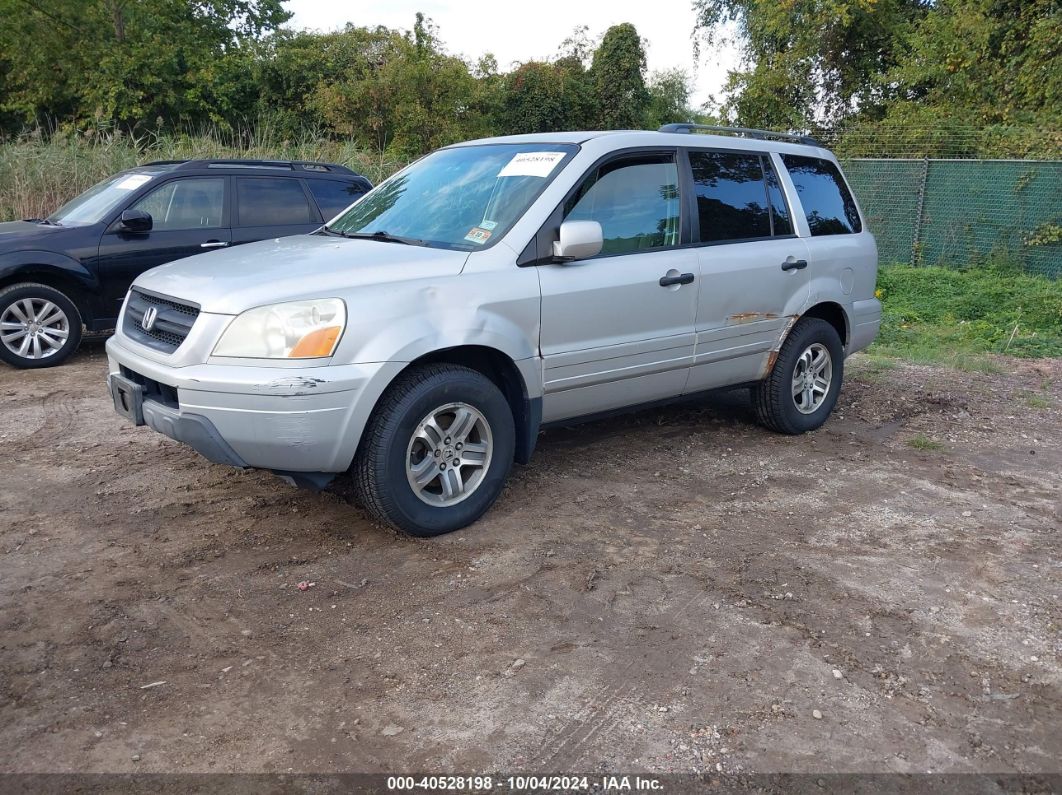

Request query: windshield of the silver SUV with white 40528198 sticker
[{"left": 326, "top": 143, "right": 577, "bottom": 250}]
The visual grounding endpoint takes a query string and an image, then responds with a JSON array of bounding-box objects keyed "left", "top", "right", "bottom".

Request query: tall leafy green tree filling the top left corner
[{"left": 0, "top": 0, "right": 291, "bottom": 128}]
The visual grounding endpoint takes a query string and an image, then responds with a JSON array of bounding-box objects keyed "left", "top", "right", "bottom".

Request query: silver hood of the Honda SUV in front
[{"left": 134, "top": 235, "right": 468, "bottom": 314}]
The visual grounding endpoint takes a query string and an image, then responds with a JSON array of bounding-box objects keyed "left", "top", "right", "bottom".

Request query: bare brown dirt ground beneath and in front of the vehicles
[{"left": 0, "top": 341, "right": 1062, "bottom": 773}]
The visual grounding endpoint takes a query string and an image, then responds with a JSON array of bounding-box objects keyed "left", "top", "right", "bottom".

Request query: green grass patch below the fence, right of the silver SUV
[{"left": 869, "top": 262, "right": 1062, "bottom": 363}]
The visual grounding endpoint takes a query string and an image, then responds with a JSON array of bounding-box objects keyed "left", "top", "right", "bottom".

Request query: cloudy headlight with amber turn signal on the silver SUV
[{"left": 213, "top": 298, "right": 346, "bottom": 359}]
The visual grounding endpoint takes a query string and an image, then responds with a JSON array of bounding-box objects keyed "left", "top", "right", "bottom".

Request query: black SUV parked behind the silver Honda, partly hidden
[{"left": 0, "top": 160, "right": 372, "bottom": 367}]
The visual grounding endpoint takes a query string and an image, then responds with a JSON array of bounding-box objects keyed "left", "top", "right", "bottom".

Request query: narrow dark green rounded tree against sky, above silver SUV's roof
[{"left": 590, "top": 22, "right": 649, "bottom": 129}]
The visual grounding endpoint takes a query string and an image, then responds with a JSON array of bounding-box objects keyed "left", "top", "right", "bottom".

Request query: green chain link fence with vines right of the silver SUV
[{"left": 817, "top": 125, "right": 1062, "bottom": 278}]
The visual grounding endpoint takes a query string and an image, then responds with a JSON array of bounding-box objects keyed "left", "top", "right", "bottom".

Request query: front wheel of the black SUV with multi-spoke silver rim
[{"left": 0, "top": 282, "right": 82, "bottom": 369}]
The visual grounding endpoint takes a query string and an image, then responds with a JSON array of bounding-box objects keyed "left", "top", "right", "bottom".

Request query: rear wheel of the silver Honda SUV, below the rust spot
[{"left": 752, "top": 317, "right": 844, "bottom": 434}]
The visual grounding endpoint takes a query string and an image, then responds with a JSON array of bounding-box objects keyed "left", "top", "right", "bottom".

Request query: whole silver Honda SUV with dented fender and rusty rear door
[{"left": 107, "top": 125, "right": 880, "bottom": 536}]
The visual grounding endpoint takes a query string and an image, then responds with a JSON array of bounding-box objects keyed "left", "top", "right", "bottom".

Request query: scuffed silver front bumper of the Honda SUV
[{"left": 107, "top": 336, "right": 400, "bottom": 472}]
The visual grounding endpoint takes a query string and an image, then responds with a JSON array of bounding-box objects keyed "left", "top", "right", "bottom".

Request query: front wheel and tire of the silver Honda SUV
[{"left": 353, "top": 364, "right": 515, "bottom": 537}]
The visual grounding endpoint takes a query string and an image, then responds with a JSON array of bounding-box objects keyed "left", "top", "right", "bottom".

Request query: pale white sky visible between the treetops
[{"left": 285, "top": 0, "right": 738, "bottom": 107}]
